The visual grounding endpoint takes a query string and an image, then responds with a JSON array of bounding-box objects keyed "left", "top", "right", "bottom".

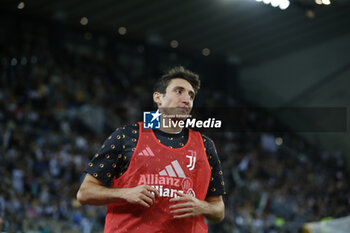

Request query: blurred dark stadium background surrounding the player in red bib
[{"left": 0, "top": 0, "right": 350, "bottom": 233}]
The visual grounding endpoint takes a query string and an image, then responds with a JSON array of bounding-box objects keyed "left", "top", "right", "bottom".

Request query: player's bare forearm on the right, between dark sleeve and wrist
[{"left": 203, "top": 200, "right": 225, "bottom": 222}]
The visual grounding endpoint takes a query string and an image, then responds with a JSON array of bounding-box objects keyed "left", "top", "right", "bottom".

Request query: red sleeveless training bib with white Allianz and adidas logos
[{"left": 104, "top": 123, "right": 211, "bottom": 233}]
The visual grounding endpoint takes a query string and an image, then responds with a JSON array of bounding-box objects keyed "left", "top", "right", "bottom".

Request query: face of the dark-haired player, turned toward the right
[{"left": 153, "top": 78, "right": 195, "bottom": 115}]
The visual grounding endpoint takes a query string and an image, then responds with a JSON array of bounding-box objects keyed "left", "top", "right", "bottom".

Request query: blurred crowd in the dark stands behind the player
[{"left": 0, "top": 16, "right": 350, "bottom": 233}]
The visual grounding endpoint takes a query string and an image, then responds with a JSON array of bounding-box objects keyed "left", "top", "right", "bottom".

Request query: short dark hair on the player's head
[{"left": 153, "top": 66, "right": 201, "bottom": 94}]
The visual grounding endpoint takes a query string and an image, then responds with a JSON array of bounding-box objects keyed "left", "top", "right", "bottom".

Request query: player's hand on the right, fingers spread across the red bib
[{"left": 169, "top": 192, "right": 208, "bottom": 218}]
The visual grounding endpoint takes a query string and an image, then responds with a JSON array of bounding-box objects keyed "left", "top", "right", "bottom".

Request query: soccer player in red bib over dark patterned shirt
[{"left": 77, "top": 66, "right": 225, "bottom": 233}]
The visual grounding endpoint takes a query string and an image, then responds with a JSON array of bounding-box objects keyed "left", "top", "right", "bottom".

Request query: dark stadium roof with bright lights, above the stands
[{"left": 1, "top": 0, "right": 350, "bottom": 65}]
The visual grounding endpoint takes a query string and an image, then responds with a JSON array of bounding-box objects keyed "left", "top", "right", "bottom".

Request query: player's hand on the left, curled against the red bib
[{"left": 123, "top": 185, "right": 159, "bottom": 207}]
